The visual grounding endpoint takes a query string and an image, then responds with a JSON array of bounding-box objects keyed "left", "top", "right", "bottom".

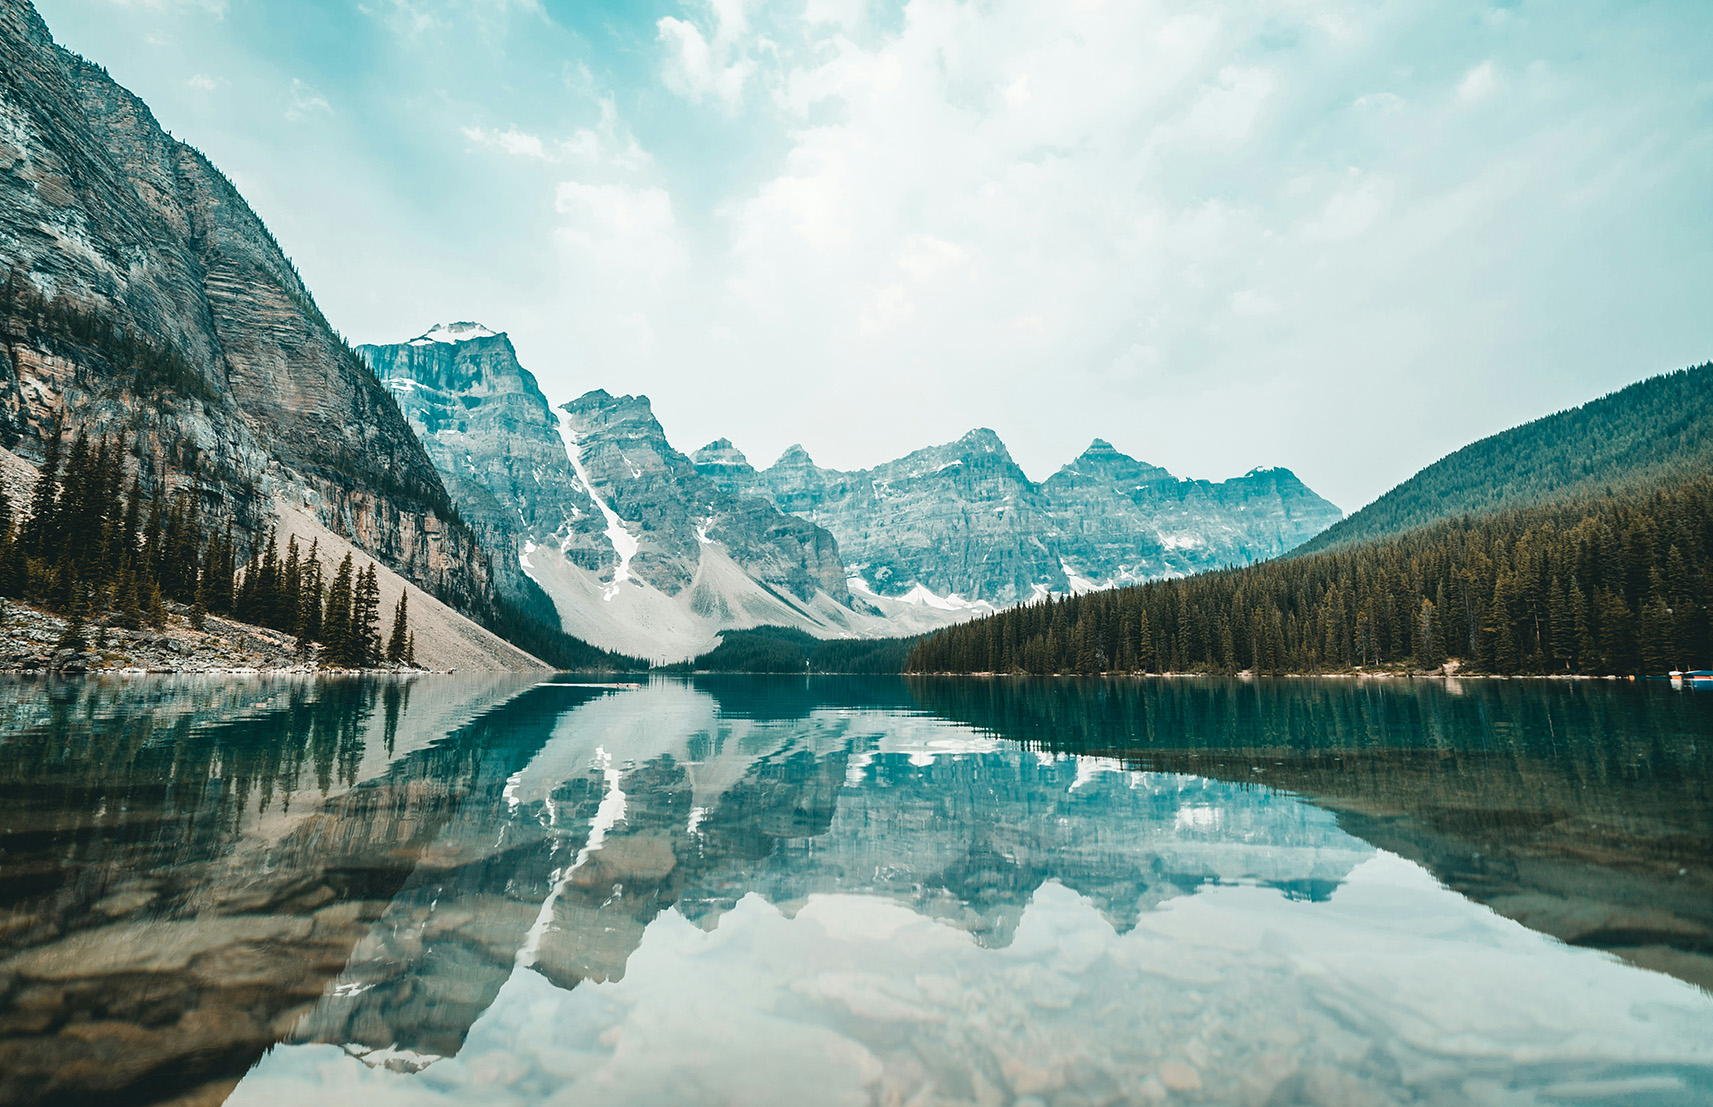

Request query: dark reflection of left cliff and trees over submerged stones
[{"left": 0, "top": 679, "right": 579, "bottom": 1104}]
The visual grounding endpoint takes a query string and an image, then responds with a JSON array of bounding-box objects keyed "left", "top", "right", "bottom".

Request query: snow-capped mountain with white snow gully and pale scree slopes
[{"left": 360, "top": 324, "right": 944, "bottom": 660}]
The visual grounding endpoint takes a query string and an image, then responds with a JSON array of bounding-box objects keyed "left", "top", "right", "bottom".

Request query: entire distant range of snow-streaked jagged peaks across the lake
[{"left": 358, "top": 322, "right": 1341, "bottom": 661}]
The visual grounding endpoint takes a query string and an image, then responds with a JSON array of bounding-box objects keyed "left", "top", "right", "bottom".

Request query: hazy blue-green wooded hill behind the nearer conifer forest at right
[{"left": 1295, "top": 363, "right": 1713, "bottom": 557}]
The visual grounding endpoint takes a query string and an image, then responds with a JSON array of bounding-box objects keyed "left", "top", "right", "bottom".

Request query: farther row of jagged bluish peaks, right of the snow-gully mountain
[{"left": 695, "top": 430, "right": 1341, "bottom": 605}]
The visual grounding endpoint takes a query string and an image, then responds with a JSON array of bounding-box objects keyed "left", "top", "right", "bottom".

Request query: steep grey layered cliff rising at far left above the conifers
[{"left": 0, "top": 0, "right": 488, "bottom": 608}]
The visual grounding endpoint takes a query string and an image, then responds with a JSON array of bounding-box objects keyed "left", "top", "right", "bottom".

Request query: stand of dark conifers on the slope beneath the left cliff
[{"left": 0, "top": 428, "right": 415, "bottom": 668}]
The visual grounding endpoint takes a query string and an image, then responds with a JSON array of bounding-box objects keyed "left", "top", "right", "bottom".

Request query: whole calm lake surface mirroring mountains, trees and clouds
[{"left": 0, "top": 677, "right": 1713, "bottom": 1107}]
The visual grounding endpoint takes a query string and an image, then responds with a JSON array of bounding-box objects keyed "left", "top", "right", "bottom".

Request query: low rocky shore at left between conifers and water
[{"left": 0, "top": 600, "right": 416, "bottom": 675}]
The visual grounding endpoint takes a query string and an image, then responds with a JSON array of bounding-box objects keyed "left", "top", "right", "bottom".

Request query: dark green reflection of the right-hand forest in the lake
[{"left": 911, "top": 679, "right": 1713, "bottom": 989}]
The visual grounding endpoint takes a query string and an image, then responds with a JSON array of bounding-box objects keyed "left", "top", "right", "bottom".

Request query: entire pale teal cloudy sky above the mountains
[{"left": 38, "top": 0, "right": 1713, "bottom": 511}]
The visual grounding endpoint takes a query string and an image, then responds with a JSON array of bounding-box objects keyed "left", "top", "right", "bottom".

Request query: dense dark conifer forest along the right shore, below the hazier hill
[{"left": 906, "top": 478, "right": 1713, "bottom": 675}]
